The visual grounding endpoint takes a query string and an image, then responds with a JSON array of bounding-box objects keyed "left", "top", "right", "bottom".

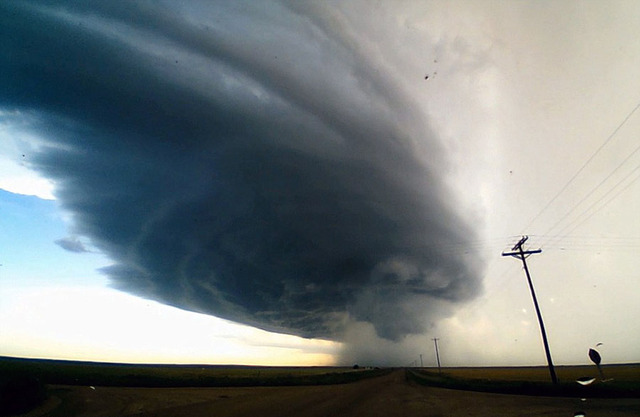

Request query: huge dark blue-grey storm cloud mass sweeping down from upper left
[{"left": 0, "top": 2, "right": 479, "bottom": 340}]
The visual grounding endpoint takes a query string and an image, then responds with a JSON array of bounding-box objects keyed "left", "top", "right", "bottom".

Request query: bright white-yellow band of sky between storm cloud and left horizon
[{"left": 0, "top": 287, "right": 339, "bottom": 366}]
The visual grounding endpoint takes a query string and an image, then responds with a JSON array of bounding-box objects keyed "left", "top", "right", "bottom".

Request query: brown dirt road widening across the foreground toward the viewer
[{"left": 28, "top": 371, "right": 640, "bottom": 417}]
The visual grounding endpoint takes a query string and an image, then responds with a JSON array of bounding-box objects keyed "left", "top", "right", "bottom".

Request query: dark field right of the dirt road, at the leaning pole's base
[{"left": 407, "top": 364, "right": 640, "bottom": 398}]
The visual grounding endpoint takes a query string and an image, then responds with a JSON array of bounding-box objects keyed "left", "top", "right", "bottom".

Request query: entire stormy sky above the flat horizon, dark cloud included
[{"left": 0, "top": 1, "right": 640, "bottom": 365}]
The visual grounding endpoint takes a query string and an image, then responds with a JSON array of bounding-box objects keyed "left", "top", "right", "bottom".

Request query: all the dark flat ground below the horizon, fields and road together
[{"left": 5, "top": 358, "right": 640, "bottom": 417}]
